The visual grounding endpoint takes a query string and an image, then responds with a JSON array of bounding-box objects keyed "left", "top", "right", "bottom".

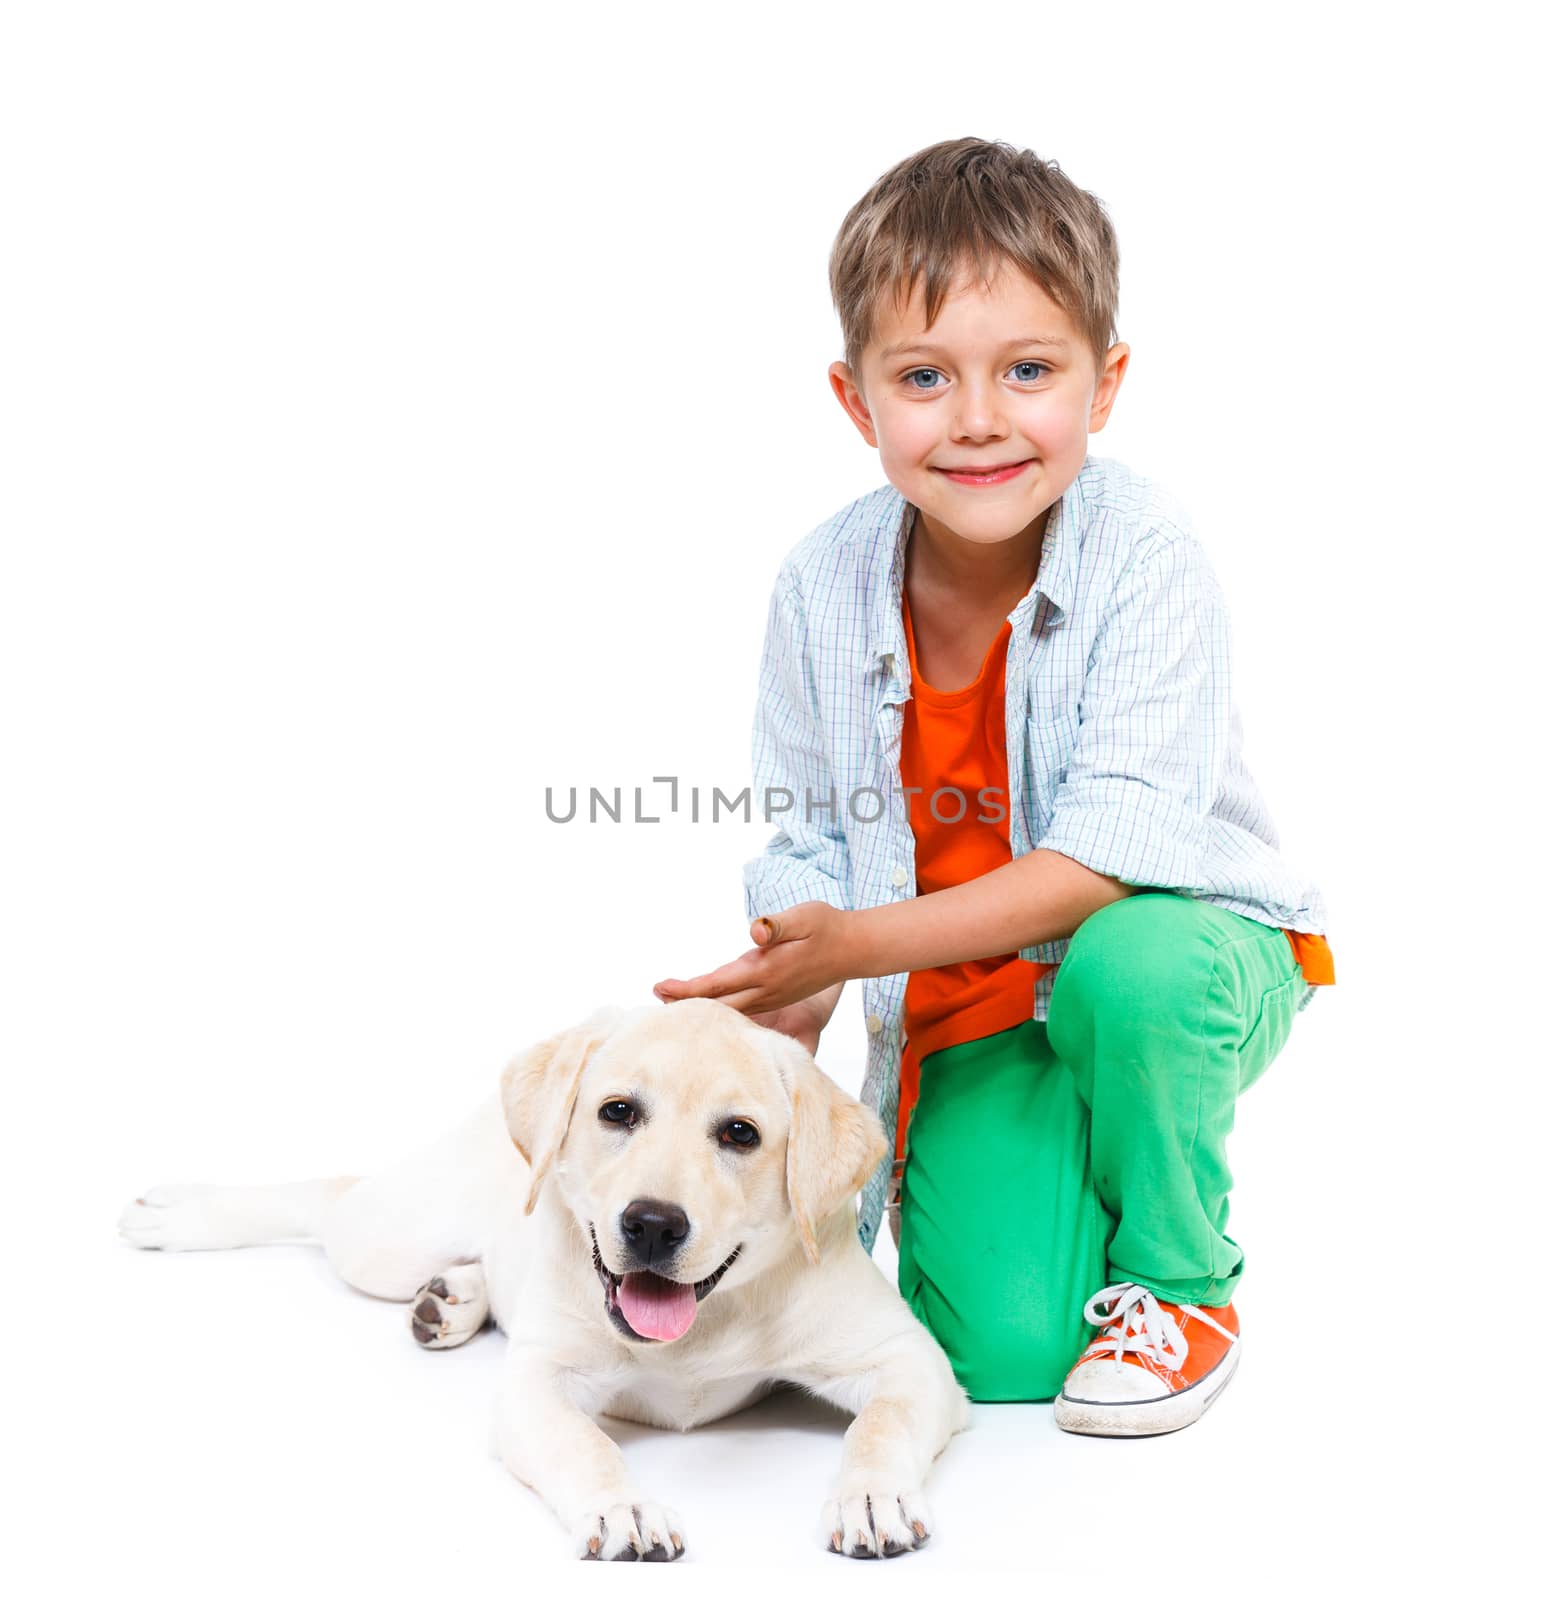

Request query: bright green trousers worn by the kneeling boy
[{"left": 899, "top": 893, "right": 1306, "bottom": 1400}]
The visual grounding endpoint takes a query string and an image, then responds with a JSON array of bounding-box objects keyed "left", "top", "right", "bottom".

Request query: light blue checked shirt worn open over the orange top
[{"left": 744, "top": 456, "right": 1326, "bottom": 1251}]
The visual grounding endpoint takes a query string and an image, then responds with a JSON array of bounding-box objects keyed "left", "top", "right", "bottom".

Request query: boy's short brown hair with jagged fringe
[{"left": 830, "top": 139, "right": 1120, "bottom": 393}]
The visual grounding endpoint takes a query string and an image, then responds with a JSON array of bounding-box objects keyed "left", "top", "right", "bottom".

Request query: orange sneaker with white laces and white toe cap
[{"left": 1056, "top": 1283, "right": 1238, "bottom": 1438}]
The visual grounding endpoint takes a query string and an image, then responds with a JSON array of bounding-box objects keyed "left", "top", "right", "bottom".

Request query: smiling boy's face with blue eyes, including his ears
[{"left": 830, "top": 261, "right": 1130, "bottom": 566}]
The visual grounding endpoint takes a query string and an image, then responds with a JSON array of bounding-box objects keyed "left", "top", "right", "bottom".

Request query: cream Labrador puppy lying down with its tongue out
[{"left": 118, "top": 1000, "right": 968, "bottom": 1562}]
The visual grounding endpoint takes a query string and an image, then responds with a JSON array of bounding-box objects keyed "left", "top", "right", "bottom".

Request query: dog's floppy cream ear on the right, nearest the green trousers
[{"left": 776, "top": 1034, "right": 890, "bottom": 1266}]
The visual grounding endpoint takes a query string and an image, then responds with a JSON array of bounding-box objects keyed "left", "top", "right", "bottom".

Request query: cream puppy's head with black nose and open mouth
[{"left": 502, "top": 1000, "right": 888, "bottom": 1341}]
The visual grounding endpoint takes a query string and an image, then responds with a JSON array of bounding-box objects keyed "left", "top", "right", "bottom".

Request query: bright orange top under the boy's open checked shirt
[{"left": 896, "top": 590, "right": 1334, "bottom": 1158}]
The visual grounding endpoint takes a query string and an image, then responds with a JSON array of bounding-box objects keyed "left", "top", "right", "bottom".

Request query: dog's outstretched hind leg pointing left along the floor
[{"left": 118, "top": 1178, "right": 358, "bottom": 1250}]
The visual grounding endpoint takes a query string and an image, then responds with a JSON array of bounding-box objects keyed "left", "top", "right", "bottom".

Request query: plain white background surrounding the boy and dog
[{"left": 0, "top": 3, "right": 1539, "bottom": 1600}]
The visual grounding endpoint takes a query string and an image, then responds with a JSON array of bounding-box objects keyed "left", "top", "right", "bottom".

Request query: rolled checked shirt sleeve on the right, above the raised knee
[{"left": 1037, "top": 538, "right": 1232, "bottom": 893}]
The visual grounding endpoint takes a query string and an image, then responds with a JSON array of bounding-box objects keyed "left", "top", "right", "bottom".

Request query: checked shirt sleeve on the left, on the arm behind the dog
[{"left": 744, "top": 563, "right": 850, "bottom": 920}]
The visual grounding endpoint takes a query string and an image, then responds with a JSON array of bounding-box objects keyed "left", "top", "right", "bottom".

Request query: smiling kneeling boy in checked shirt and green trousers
[{"left": 654, "top": 139, "right": 1334, "bottom": 1435}]
